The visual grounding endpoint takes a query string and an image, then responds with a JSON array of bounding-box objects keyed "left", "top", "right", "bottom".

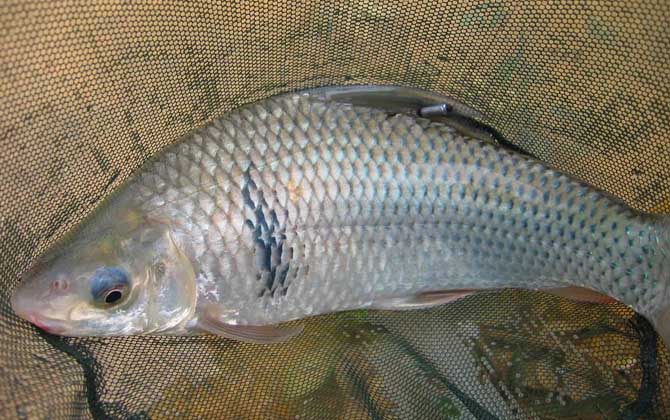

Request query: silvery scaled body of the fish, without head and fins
[{"left": 11, "top": 90, "right": 670, "bottom": 342}]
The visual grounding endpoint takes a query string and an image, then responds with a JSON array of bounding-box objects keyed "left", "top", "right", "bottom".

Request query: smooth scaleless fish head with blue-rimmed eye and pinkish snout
[{"left": 11, "top": 203, "right": 196, "bottom": 336}]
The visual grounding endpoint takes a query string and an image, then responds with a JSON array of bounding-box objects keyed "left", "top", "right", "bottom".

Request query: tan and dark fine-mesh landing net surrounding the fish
[{"left": 0, "top": 0, "right": 670, "bottom": 419}]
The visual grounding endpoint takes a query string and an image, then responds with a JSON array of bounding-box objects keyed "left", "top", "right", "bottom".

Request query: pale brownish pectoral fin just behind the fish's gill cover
[{"left": 198, "top": 309, "right": 303, "bottom": 344}]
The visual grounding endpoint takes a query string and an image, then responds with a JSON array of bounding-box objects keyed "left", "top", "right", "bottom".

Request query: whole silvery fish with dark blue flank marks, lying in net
[{"left": 11, "top": 86, "right": 670, "bottom": 344}]
